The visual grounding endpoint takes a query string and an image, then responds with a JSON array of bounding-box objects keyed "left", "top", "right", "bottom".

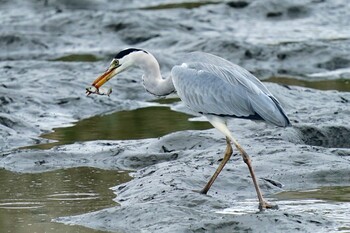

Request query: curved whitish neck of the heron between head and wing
[{"left": 137, "top": 53, "right": 175, "bottom": 96}]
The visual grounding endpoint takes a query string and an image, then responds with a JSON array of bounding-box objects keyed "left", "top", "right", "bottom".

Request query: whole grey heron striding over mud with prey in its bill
[{"left": 87, "top": 48, "right": 290, "bottom": 210}]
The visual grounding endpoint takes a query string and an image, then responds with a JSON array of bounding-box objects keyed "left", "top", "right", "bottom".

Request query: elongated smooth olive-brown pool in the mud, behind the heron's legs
[{"left": 31, "top": 107, "right": 211, "bottom": 149}]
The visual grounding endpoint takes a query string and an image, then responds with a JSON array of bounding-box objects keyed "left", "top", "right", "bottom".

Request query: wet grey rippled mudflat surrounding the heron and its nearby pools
[{"left": 0, "top": 0, "right": 350, "bottom": 232}]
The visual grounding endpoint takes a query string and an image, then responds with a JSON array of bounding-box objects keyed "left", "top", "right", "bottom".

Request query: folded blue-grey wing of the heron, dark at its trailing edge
[{"left": 171, "top": 63, "right": 289, "bottom": 126}]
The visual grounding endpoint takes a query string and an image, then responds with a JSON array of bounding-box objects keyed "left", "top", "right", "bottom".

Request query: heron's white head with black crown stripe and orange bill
[{"left": 92, "top": 48, "right": 147, "bottom": 89}]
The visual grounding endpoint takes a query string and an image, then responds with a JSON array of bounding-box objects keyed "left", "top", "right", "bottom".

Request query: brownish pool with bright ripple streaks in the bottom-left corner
[{"left": 0, "top": 167, "right": 130, "bottom": 233}]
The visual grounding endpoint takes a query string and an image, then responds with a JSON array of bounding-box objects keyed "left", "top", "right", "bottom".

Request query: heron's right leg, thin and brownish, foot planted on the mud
[{"left": 232, "top": 138, "right": 278, "bottom": 210}]
